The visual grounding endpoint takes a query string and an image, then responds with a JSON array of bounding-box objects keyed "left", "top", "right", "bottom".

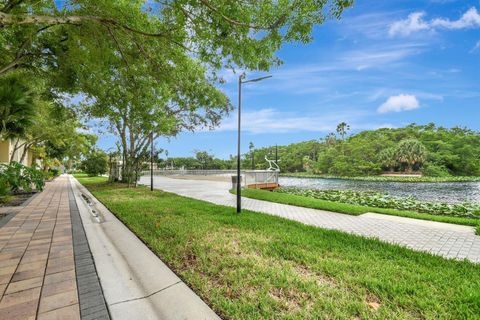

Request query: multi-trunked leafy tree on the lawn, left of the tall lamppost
[{"left": 84, "top": 51, "right": 231, "bottom": 184}]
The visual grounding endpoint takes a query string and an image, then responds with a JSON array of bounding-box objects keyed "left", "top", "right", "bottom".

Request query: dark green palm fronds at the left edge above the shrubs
[{"left": 0, "top": 77, "right": 36, "bottom": 139}]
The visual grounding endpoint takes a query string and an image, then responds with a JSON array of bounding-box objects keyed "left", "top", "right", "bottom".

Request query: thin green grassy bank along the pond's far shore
[{"left": 280, "top": 172, "right": 480, "bottom": 183}]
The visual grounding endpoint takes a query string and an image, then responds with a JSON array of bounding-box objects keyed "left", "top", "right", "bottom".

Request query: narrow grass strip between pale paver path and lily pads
[{"left": 236, "top": 189, "right": 480, "bottom": 234}]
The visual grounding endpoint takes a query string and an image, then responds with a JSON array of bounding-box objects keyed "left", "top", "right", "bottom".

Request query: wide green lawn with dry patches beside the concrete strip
[{"left": 74, "top": 177, "right": 480, "bottom": 319}]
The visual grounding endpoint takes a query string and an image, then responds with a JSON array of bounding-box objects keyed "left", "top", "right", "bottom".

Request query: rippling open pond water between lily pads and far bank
[{"left": 279, "top": 177, "right": 480, "bottom": 203}]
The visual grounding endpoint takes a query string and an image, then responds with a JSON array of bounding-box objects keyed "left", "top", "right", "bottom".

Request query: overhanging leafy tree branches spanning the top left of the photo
[{"left": 0, "top": 0, "right": 353, "bottom": 79}]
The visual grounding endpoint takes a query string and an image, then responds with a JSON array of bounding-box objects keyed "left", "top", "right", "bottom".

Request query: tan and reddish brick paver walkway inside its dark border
[{"left": 0, "top": 176, "right": 97, "bottom": 320}]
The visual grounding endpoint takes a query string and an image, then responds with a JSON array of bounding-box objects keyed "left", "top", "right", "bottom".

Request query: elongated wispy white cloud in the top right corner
[{"left": 388, "top": 7, "right": 480, "bottom": 37}]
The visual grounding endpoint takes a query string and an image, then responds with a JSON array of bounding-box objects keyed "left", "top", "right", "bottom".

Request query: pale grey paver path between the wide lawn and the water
[{"left": 140, "top": 177, "right": 480, "bottom": 263}]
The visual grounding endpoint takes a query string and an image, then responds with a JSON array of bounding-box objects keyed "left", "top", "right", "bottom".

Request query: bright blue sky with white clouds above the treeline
[{"left": 94, "top": 0, "right": 480, "bottom": 158}]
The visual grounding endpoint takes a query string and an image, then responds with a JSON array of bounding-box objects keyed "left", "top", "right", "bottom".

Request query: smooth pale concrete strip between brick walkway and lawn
[{"left": 71, "top": 178, "right": 220, "bottom": 320}]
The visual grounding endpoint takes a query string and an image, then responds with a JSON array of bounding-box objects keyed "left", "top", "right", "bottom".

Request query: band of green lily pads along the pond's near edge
[{"left": 274, "top": 188, "right": 480, "bottom": 219}]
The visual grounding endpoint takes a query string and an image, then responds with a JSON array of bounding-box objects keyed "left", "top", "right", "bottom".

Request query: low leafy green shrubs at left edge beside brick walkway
[{"left": 0, "top": 162, "right": 45, "bottom": 196}]
